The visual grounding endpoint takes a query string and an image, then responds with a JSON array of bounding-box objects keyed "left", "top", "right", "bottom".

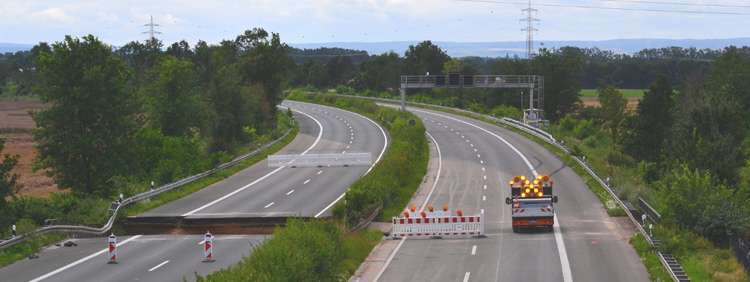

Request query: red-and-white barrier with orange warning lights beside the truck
[{"left": 391, "top": 208, "right": 485, "bottom": 238}]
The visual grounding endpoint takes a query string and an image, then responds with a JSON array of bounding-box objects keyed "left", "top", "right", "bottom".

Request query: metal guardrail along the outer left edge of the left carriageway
[{"left": 0, "top": 129, "right": 292, "bottom": 250}]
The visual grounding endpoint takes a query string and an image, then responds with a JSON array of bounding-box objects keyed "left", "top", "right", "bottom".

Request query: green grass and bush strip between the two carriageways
[{"left": 191, "top": 90, "right": 429, "bottom": 281}]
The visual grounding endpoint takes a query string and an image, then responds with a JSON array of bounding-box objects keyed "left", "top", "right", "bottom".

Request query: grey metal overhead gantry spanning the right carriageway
[{"left": 401, "top": 72, "right": 544, "bottom": 123}]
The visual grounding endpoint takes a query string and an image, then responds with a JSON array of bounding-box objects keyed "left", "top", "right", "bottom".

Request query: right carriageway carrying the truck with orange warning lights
[{"left": 372, "top": 108, "right": 649, "bottom": 282}]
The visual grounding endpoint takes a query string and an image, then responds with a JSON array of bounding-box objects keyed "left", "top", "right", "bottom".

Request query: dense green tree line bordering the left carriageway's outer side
[{"left": 0, "top": 28, "right": 293, "bottom": 229}]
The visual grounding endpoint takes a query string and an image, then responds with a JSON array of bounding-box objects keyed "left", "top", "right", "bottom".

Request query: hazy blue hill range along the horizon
[{"left": 5, "top": 38, "right": 750, "bottom": 58}]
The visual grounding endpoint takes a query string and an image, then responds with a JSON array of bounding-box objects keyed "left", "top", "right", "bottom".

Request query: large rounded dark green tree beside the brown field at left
[{"left": 31, "top": 35, "right": 139, "bottom": 196}]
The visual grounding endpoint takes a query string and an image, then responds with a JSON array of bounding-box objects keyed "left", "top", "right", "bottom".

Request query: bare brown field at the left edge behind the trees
[{"left": 0, "top": 102, "right": 57, "bottom": 198}]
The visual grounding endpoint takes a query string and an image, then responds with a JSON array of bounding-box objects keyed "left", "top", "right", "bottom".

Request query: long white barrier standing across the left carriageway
[{"left": 268, "top": 153, "right": 372, "bottom": 167}]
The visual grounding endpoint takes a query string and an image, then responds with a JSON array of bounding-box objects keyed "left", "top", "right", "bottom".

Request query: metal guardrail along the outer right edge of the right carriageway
[{"left": 340, "top": 95, "right": 689, "bottom": 282}]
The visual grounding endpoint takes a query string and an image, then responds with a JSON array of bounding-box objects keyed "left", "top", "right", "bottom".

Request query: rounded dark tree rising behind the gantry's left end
[{"left": 403, "top": 40, "right": 450, "bottom": 75}]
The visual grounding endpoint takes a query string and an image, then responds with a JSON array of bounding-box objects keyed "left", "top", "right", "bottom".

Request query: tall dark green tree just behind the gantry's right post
[{"left": 532, "top": 48, "right": 582, "bottom": 123}]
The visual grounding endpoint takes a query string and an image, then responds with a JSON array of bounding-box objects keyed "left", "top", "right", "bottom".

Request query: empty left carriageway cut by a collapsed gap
[{"left": 0, "top": 101, "right": 388, "bottom": 282}]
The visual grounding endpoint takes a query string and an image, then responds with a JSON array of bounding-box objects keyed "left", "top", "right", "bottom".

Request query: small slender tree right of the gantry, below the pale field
[{"left": 597, "top": 84, "right": 628, "bottom": 148}]
